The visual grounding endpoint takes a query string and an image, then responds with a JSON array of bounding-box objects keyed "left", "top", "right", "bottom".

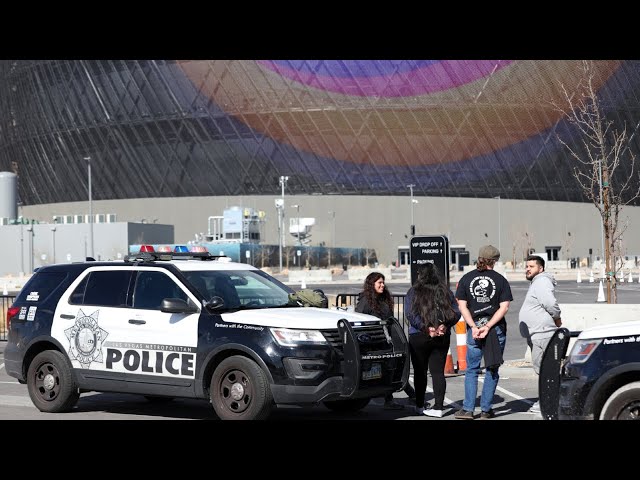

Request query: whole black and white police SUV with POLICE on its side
[{"left": 4, "top": 252, "right": 409, "bottom": 419}]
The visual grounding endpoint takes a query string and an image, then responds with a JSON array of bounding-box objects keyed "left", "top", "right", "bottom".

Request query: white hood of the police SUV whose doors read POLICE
[{"left": 222, "top": 307, "right": 380, "bottom": 330}]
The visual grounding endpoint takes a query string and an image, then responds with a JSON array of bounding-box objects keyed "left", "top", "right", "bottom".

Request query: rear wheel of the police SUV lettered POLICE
[{"left": 27, "top": 350, "right": 80, "bottom": 413}]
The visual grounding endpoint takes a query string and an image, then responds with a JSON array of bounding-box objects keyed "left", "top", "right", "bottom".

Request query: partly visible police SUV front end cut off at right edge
[{"left": 539, "top": 321, "right": 640, "bottom": 420}]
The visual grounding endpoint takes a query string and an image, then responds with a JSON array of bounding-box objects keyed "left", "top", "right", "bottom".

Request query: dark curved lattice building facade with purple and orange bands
[{"left": 0, "top": 60, "right": 640, "bottom": 268}]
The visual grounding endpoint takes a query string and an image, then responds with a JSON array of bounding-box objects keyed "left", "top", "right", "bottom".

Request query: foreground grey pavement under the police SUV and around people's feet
[{"left": 0, "top": 342, "right": 542, "bottom": 422}]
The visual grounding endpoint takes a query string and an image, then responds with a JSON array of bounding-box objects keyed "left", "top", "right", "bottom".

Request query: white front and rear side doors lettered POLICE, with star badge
[{"left": 52, "top": 266, "right": 199, "bottom": 393}]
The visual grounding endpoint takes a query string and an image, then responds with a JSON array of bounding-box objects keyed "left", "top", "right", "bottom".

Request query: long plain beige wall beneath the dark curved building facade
[{"left": 20, "top": 194, "right": 640, "bottom": 270}]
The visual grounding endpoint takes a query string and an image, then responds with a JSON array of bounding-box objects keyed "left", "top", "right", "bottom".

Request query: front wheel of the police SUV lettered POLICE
[{"left": 209, "top": 355, "right": 273, "bottom": 420}]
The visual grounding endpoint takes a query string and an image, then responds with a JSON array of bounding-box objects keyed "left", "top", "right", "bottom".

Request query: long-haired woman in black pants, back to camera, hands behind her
[{"left": 404, "top": 263, "right": 460, "bottom": 418}]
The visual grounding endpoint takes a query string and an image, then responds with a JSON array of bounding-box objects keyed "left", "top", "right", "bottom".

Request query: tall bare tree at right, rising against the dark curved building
[{"left": 551, "top": 60, "right": 640, "bottom": 303}]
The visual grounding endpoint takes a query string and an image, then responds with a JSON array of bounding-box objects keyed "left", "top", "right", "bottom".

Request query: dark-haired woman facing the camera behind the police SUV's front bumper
[{"left": 355, "top": 272, "right": 416, "bottom": 410}]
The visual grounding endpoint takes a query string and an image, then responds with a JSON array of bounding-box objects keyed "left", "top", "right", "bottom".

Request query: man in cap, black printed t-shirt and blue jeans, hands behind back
[{"left": 455, "top": 245, "right": 513, "bottom": 420}]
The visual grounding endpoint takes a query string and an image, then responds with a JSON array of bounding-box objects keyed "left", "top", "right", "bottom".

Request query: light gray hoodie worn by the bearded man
[{"left": 519, "top": 272, "right": 560, "bottom": 338}]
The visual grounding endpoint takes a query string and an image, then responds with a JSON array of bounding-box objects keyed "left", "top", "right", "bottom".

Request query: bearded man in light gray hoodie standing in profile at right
[{"left": 519, "top": 255, "right": 562, "bottom": 413}]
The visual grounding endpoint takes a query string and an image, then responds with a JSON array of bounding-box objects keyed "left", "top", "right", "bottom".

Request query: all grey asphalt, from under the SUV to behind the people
[{"left": 0, "top": 281, "right": 640, "bottom": 423}]
